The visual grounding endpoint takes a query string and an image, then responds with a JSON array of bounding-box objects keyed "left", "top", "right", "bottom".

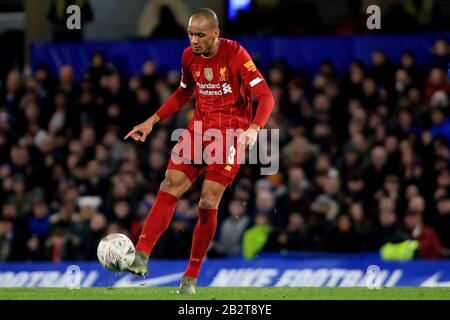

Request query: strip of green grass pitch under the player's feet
[{"left": 0, "top": 287, "right": 450, "bottom": 300}]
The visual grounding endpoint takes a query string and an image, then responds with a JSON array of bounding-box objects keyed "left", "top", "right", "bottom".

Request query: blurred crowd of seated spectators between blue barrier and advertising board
[{"left": 0, "top": 40, "right": 450, "bottom": 262}]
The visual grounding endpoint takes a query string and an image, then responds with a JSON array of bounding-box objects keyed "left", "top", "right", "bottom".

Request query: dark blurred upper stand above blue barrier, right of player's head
[{"left": 227, "top": 0, "right": 450, "bottom": 36}]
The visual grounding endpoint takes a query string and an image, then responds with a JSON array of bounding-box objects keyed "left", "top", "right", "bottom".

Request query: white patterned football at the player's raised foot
[{"left": 97, "top": 233, "right": 136, "bottom": 272}]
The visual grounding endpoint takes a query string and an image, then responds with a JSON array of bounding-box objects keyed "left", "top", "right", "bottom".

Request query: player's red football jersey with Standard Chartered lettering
[{"left": 180, "top": 38, "right": 265, "bottom": 131}]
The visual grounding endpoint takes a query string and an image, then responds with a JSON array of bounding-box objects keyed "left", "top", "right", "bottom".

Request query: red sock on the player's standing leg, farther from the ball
[{"left": 184, "top": 208, "right": 217, "bottom": 278}]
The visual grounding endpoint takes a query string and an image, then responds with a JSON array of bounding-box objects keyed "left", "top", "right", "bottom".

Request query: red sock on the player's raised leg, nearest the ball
[{"left": 136, "top": 190, "right": 178, "bottom": 255}]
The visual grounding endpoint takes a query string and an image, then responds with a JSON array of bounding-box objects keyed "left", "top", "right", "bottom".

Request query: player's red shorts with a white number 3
[{"left": 167, "top": 129, "right": 240, "bottom": 187}]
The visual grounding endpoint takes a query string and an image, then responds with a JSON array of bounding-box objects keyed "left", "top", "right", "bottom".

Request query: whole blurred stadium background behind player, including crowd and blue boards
[{"left": 0, "top": 0, "right": 450, "bottom": 287}]
